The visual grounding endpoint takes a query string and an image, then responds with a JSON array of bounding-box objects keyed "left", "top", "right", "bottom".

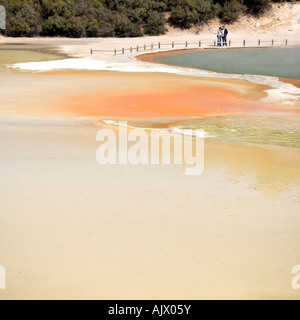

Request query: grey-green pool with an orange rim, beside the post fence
[{"left": 155, "top": 47, "right": 300, "bottom": 79}]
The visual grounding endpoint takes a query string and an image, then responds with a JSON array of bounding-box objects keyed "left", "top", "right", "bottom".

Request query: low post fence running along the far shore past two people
[{"left": 91, "top": 39, "right": 289, "bottom": 56}]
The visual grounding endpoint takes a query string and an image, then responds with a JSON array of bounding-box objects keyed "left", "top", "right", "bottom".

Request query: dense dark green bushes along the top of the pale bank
[{"left": 0, "top": 0, "right": 292, "bottom": 38}]
